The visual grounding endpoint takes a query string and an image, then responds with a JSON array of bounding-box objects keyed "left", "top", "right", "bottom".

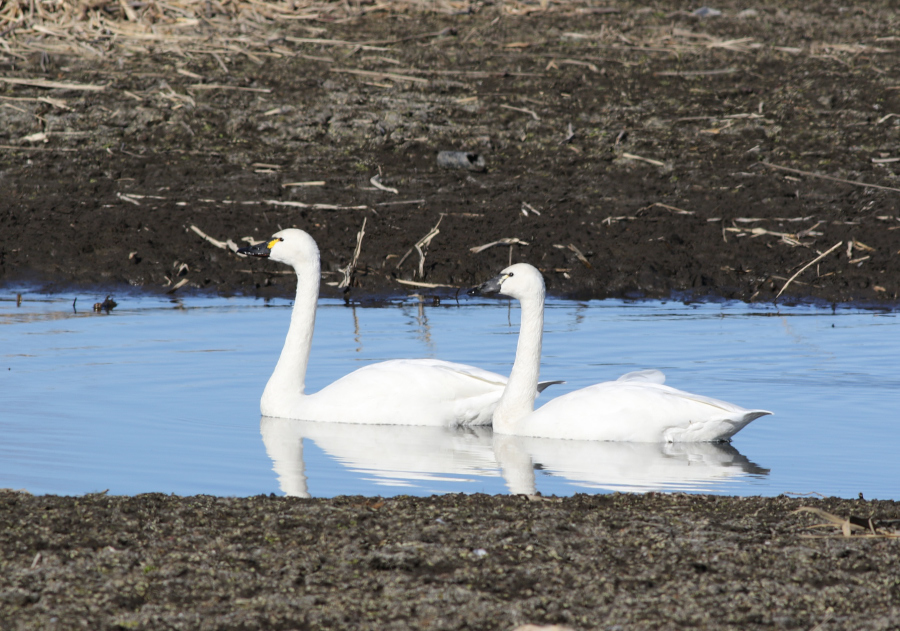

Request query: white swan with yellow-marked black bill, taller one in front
[{"left": 238, "top": 228, "right": 559, "bottom": 425}]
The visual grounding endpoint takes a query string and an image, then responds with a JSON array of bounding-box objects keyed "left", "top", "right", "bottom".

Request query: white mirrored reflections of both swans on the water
[{"left": 260, "top": 416, "right": 769, "bottom": 497}]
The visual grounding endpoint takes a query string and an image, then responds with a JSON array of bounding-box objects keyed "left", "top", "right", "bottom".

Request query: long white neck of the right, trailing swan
[{"left": 493, "top": 288, "right": 544, "bottom": 434}]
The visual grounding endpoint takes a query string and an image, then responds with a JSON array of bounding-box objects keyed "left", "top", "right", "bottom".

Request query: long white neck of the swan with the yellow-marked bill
[{"left": 260, "top": 258, "right": 320, "bottom": 416}]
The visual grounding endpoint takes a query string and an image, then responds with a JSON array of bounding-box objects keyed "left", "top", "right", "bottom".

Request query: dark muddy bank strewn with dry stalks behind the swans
[{"left": 0, "top": 1, "right": 900, "bottom": 306}]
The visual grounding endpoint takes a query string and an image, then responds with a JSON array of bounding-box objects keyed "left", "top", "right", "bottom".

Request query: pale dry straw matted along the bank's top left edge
[{"left": 0, "top": 0, "right": 604, "bottom": 60}]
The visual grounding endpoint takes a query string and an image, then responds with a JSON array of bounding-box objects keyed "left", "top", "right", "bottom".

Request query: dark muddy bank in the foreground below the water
[{"left": 0, "top": 492, "right": 900, "bottom": 629}]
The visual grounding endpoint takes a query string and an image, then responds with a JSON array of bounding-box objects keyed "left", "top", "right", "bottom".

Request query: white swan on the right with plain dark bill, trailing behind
[{"left": 473, "top": 263, "right": 771, "bottom": 442}]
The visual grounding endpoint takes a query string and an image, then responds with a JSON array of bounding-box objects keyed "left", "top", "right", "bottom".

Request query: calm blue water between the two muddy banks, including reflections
[{"left": 0, "top": 290, "right": 900, "bottom": 500}]
